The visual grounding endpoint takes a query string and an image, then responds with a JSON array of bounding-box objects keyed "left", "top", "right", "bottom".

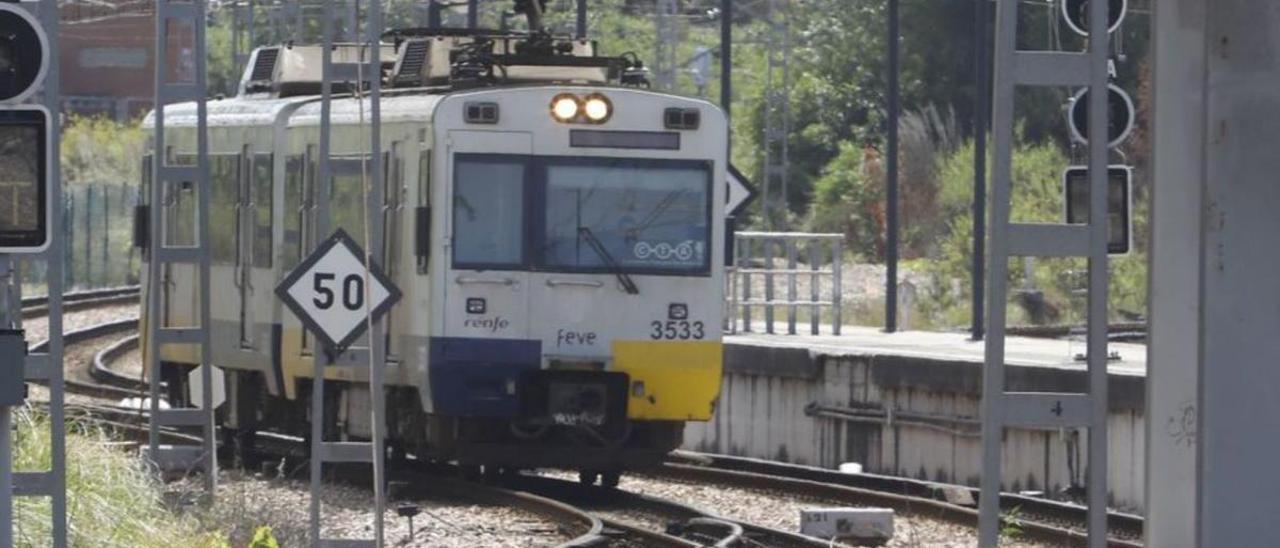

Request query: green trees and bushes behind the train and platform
[{"left": 172, "top": 0, "right": 1151, "bottom": 329}]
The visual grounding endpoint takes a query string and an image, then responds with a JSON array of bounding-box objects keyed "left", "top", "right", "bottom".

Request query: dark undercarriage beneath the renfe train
[{"left": 161, "top": 364, "right": 684, "bottom": 487}]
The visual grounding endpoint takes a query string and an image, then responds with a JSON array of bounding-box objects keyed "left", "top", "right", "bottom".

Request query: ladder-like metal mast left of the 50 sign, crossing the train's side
[{"left": 143, "top": 0, "right": 218, "bottom": 497}]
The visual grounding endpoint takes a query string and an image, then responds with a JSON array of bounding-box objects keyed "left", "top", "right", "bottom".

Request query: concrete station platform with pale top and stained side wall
[{"left": 685, "top": 321, "right": 1157, "bottom": 511}]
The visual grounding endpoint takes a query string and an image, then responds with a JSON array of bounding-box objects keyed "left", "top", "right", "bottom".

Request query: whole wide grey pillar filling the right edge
[{"left": 1147, "top": 0, "right": 1280, "bottom": 547}]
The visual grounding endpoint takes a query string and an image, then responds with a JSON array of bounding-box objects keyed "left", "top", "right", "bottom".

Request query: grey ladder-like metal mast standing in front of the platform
[{"left": 979, "top": 0, "right": 1108, "bottom": 548}]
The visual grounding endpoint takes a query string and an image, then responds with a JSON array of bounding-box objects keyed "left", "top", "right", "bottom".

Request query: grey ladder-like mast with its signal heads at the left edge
[{"left": 0, "top": 0, "right": 67, "bottom": 548}]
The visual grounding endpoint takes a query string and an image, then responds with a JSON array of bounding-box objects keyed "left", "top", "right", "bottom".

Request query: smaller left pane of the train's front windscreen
[{"left": 453, "top": 155, "right": 526, "bottom": 269}]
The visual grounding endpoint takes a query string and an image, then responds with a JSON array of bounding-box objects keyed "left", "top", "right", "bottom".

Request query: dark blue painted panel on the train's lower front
[{"left": 428, "top": 337, "right": 543, "bottom": 417}]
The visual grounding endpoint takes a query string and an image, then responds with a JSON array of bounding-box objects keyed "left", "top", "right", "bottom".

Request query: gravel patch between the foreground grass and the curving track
[{"left": 168, "top": 472, "right": 567, "bottom": 548}]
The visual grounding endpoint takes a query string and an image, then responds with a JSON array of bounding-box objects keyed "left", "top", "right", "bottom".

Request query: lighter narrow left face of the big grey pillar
[{"left": 1144, "top": 0, "right": 1206, "bottom": 548}]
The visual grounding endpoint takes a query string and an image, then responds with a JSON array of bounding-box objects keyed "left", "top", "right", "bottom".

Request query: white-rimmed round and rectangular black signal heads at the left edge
[{"left": 0, "top": 4, "right": 54, "bottom": 254}]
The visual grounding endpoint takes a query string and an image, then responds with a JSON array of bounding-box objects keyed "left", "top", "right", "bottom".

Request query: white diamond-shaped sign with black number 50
[{"left": 275, "top": 229, "right": 401, "bottom": 352}]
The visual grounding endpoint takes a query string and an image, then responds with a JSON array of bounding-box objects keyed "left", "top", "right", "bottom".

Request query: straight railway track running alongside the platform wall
[{"left": 654, "top": 451, "right": 1143, "bottom": 548}]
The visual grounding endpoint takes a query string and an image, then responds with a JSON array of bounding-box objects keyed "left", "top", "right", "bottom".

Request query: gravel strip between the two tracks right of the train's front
[{"left": 547, "top": 472, "right": 1044, "bottom": 548}]
